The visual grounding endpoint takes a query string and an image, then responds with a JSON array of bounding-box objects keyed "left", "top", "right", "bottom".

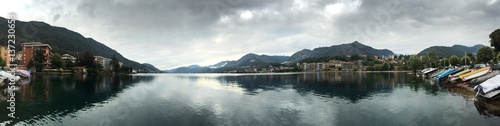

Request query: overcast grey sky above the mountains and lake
[{"left": 0, "top": 0, "right": 500, "bottom": 69}]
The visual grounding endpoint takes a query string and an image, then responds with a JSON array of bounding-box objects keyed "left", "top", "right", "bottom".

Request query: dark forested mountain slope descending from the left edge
[{"left": 0, "top": 17, "right": 161, "bottom": 72}]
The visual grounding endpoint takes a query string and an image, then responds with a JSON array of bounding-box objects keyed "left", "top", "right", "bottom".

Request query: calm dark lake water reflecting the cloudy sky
[{"left": 0, "top": 72, "right": 500, "bottom": 126}]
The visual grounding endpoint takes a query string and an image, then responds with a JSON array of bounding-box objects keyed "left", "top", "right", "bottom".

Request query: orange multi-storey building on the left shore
[{"left": 21, "top": 42, "right": 53, "bottom": 67}]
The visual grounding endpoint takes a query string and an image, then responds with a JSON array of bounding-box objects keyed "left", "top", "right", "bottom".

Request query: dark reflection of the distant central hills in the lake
[{"left": 212, "top": 72, "right": 439, "bottom": 102}]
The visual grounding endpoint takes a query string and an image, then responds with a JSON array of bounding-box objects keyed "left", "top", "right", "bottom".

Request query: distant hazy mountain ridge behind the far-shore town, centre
[{"left": 164, "top": 41, "right": 394, "bottom": 73}]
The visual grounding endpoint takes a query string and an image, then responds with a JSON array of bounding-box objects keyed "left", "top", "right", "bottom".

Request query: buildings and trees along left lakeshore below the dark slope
[{"left": 0, "top": 42, "right": 137, "bottom": 74}]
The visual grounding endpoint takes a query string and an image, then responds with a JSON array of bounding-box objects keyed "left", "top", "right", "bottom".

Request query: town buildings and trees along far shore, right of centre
[{"left": 224, "top": 50, "right": 472, "bottom": 73}]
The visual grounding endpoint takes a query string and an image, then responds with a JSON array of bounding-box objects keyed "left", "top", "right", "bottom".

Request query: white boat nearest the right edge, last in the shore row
[{"left": 474, "top": 75, "right": 500, "bottom": 99}]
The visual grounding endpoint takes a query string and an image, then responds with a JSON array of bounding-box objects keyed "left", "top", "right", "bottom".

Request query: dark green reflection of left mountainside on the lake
[{"left": 0, "top": 75, "right": 154, "bottom": 122}]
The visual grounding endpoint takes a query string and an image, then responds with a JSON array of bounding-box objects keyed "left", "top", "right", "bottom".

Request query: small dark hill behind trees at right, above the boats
[{"left": 418, "top": 44, "right": 484, "bottom": 57}]
